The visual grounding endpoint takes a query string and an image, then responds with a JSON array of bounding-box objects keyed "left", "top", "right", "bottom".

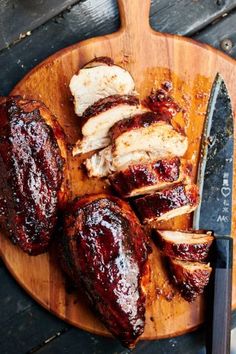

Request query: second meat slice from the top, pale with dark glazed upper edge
[{"left": 73, "top": 95, "right": 144, "bottom": 156}]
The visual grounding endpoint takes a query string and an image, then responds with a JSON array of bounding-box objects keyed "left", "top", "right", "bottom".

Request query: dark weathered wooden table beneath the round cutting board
[{"left": 0, "top": 0, "right": 236, "bottom": 354}]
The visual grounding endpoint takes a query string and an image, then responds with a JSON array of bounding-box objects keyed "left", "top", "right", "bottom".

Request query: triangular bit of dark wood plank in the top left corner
[{"left": 0, "top": 0, "right": 78, "bottom": 49}]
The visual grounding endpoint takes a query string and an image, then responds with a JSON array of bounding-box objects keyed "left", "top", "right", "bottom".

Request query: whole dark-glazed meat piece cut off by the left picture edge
[{"left": 0, "top": 97, "right": 66, "bottom": 255}]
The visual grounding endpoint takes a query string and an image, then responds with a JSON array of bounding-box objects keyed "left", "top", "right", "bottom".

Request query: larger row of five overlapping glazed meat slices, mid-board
[{"left": 70, "top": 57, "right": 198, "bottom": 223}]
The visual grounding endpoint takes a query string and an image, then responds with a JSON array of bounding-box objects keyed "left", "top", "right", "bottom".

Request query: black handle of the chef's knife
[{"left": 206, "top": 236, "right": 233, "bottom": 354}]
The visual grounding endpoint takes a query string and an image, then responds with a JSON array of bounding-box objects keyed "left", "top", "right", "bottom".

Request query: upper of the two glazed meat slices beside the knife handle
[{"left": 153, "top": 230, "right": 214, "bottom": 262}]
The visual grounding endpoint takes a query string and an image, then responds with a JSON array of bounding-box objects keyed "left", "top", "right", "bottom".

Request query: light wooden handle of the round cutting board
[{"left": 117, "top": 0, "right": 151, "bottom": 33}]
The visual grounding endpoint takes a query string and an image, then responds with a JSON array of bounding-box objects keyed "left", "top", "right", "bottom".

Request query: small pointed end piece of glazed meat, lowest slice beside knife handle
[{"left": 169, "top": 258, "right": 212, "bottom": 302}]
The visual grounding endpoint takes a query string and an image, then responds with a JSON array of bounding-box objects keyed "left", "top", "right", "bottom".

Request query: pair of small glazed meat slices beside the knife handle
[{"left": 153, "top": 230, "right": 214, "bottom": 302}]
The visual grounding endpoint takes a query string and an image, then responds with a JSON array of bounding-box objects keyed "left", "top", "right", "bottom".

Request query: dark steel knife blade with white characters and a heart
[{"left": 193, "top": 74, "right": 234, "bottom": 236}]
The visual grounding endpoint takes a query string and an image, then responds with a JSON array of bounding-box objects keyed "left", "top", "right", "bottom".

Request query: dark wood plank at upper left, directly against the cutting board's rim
[{"left": 0, "top": 0, "right": 119, "bottom": 95}]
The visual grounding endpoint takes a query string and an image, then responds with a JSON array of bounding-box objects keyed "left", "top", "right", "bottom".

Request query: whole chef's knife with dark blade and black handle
[{"left": 193, "top": 74, "right": 233, "bottom": 354}]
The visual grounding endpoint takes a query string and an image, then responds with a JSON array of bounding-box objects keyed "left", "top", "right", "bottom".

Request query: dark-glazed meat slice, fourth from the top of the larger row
[{"left": 109, "top": 157, "right": 192, "bottom": 198}]
